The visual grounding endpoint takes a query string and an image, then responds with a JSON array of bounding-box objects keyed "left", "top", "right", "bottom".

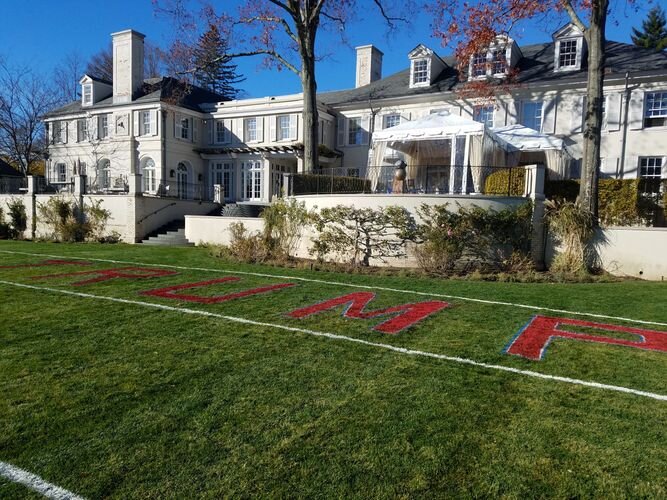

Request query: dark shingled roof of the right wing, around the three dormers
[{"left": 318, "top": 41, "right": 667, "bottom": 105}]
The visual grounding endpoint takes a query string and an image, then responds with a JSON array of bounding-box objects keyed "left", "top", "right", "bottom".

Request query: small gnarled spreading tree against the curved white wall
[{"left": 311, "top": 205, "right": 416, "bottom": 266}]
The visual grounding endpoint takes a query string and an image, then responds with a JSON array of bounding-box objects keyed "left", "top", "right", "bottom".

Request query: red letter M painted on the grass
[{"left": 288, "top": 292, "right": 449, "bottom": 334}]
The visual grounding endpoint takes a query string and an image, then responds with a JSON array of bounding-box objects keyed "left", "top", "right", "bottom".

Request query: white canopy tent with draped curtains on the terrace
[{"left": 367, "top": 111, "right": 566, "bottom": 193}]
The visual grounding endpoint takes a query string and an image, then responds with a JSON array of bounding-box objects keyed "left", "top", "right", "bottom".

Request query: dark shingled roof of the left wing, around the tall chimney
[{"left": 44, "top": 76, "right": 225, "bottom": 118}]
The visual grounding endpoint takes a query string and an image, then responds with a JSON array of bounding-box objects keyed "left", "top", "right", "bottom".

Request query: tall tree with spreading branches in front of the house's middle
[{"left": 152, "top": 0, "right": 413, "bottom": 171}]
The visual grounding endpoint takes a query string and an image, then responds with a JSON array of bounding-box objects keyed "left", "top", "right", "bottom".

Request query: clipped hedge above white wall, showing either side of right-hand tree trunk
[{"left": 544, "top": 179, "right": 665, "bottom": 226}]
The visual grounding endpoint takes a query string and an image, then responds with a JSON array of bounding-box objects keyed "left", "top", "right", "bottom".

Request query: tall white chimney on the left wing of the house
[{"left": 111, "top": 30, "right": 145, "bottom": 104}]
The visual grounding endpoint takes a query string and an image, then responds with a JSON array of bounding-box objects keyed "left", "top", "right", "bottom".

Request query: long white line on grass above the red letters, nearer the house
[{"left": 0, "top": 250, "right": 667, "bottom": 326}]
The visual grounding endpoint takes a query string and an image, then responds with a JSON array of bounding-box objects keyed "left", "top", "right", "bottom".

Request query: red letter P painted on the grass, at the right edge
[{"left": 505, "top": 316, "right": 667, "bottom": 360}]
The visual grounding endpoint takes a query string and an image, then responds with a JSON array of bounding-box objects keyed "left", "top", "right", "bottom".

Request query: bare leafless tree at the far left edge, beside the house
[{"left": 0, "top": 61, "right": 58, "bottom": 175}]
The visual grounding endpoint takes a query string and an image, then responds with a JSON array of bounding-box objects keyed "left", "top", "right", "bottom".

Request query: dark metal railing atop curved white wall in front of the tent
[{"left": 290, "top": 165, "right": 526, "bottom": 196}]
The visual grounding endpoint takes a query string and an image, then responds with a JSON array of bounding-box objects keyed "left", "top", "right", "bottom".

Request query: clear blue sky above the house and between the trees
[{"left": 0, "top": 0, "right": 656, "bottom": 97}]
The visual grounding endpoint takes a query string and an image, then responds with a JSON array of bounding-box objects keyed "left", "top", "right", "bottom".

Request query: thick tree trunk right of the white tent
[{"left": 579, "top": 0, "right": 609, "bottom": 225}]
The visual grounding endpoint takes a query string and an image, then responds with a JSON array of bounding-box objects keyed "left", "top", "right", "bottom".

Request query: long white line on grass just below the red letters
[{"left": 0, "top": 280, "right": 667, "bottom": 401}]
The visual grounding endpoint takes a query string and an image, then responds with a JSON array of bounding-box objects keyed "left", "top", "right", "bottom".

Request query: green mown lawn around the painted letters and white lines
[{"left": 0, "top": 242, "right": 667, "bottom": 498}]
